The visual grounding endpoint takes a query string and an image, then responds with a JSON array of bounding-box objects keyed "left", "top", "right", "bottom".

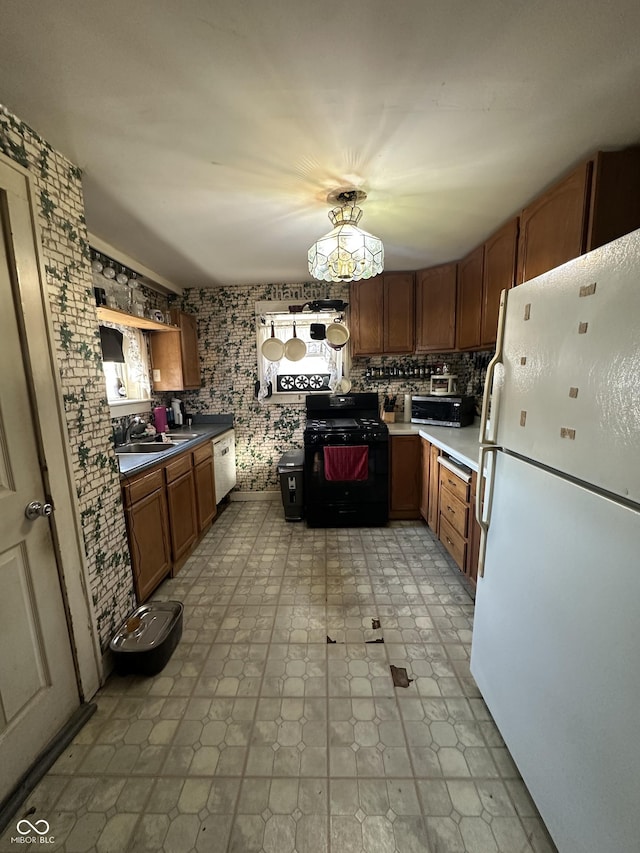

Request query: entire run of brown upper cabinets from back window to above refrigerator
[{"left": 348, "top": 146, "right": 640, "bottom": 358}]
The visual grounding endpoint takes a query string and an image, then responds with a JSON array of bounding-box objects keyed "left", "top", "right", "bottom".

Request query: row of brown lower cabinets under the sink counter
[{"left": 122, "top": 441, "right": 216, "bottom": 604}]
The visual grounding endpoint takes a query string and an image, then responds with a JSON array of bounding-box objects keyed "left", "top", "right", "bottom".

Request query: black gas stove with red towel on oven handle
[{"left": 304, "top": 393, "right": 389, "bottom": 527}]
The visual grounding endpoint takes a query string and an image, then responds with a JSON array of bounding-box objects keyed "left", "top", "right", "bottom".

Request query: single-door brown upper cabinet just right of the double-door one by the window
[{"left": 415, "top": 264, "right": 458, "bottom": 352}]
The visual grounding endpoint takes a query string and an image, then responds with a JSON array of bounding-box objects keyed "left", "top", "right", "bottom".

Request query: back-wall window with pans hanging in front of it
[{"left": 256, "top": 302, "right": 346, "bottom": 402}]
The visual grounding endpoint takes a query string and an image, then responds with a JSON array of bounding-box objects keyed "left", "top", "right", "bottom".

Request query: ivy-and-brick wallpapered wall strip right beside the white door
[{"left": 0, "top": 110, "right": 134, "bottom": 649}]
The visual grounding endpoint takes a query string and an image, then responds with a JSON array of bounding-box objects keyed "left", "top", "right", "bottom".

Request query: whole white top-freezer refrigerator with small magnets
[{"left": 471, "top": 231, "right": 640, "bottom": 853}]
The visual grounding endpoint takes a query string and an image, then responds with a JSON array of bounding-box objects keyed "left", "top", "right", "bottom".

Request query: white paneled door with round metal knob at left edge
[{"left": 0, "top": 167, "right": 80, "bottom": 799}]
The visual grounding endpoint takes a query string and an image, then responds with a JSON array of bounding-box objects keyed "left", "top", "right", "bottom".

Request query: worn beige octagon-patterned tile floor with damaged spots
[{"left": 0, "top": 501, "right": 555, "bottom": 853}]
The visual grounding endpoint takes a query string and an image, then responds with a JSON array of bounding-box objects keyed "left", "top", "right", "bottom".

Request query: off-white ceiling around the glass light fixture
[{"left": 0, "top": 0, "right": 640, "bottom": 287}]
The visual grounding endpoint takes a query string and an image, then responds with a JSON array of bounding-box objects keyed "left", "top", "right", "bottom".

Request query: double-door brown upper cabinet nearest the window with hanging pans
[{"left": 350, "top": 272, "right": 415, "bottom": 356}]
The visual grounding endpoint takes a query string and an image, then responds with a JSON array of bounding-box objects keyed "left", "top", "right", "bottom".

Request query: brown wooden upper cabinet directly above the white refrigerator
[{"left": 516, "top": 147, "right": 640, "bottom": 284}]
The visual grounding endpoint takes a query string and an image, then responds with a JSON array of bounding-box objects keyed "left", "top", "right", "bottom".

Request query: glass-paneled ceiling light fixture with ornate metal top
[{"left": 309, "top": 190, "right": 384, "bottom": 281}]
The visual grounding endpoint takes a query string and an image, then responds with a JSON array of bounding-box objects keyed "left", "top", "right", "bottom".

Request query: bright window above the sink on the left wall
[{"left": 102, "top": 326, "right": 151, "bottom": 417}]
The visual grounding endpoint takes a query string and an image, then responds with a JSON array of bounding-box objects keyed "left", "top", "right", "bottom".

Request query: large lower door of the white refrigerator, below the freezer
[{"left": 471, "top": 453, "right": 640, "bottom": 853}]
